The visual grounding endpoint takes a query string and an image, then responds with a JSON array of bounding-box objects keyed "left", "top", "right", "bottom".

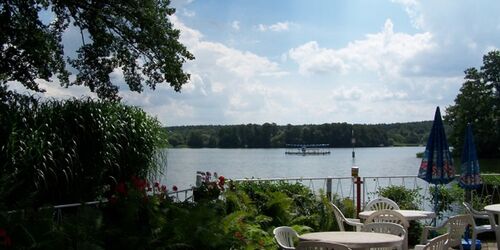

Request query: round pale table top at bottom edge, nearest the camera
[{"left": 299, "top": 231, "right": 403, "bottom": 248}]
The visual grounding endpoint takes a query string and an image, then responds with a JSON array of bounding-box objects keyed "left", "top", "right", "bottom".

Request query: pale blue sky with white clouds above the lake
[{"left": 10, "top": 0, "right": 500, "bottom": 126}]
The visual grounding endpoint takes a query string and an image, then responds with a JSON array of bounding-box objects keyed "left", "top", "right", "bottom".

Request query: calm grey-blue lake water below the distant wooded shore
[{"left": 162, "top": 147, "right": 425, "bottom": 189}]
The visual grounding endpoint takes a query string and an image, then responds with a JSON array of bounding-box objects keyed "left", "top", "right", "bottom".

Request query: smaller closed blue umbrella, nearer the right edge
[{"left": 458, "top": 123, "right": 483, "bottom": 189}]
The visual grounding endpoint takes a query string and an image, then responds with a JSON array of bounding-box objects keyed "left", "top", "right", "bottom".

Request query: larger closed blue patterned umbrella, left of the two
[{"left": 418, "top": 107, "right": 455, "bottom": 185}]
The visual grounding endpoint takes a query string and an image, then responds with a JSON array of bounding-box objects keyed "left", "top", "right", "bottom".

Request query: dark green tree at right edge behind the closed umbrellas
[{"left": 445, "top": 51, "right": 500, "bottom": 157}]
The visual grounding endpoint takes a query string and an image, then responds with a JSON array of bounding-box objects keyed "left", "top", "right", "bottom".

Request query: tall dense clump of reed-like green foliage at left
[{"left": 0, "top": 96, "right": 166, "bottom": 209}]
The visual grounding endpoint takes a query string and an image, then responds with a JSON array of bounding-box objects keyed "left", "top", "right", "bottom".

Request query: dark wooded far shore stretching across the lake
[{"left": 165, "top": 121, "right": 438, "bottom": 148}]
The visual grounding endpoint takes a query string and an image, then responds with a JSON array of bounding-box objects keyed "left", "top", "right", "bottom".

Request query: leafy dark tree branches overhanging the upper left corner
[{"left": 0, "top": 0, "right": 194, "bottom": 99}]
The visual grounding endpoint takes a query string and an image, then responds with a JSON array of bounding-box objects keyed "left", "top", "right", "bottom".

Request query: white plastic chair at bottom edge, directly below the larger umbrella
[{"left": 420, "top": 214, "right": 475, "bottom": 249}]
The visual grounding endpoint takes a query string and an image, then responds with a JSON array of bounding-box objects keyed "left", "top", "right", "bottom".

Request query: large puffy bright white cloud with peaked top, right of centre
[{"left": 288, "top": 19, "right": 435, "bottom": 77}]
